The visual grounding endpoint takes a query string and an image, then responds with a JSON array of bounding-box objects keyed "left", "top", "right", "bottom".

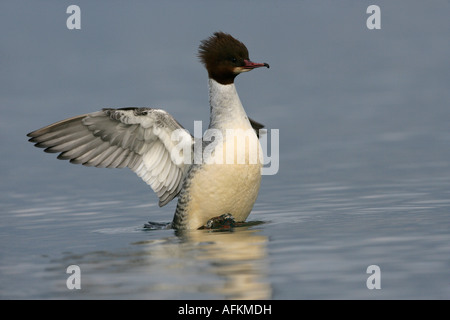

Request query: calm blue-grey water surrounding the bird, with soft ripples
[{"left": 0, "top": 1, "right": 450, "bottom": 299}]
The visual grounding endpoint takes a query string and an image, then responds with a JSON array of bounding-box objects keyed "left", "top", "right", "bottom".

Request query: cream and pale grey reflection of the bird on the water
[{"left": 138, "top": 227, "right": 271, "bottom": 299}]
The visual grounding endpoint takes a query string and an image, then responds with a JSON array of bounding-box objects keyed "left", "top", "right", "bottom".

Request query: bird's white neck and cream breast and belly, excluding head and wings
[{"left": 180, "top": 79, "right": 263, "bottom": 229}]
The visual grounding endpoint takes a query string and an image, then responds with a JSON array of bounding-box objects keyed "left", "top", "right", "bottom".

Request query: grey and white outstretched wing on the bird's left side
[{"left": 28, "top": 108, "right": 193, "bottom": 206}]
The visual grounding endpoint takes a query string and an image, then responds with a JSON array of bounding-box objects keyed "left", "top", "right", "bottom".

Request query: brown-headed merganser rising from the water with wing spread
[{"left": 27, "top": 31, "right": 269, "bottom": 230}]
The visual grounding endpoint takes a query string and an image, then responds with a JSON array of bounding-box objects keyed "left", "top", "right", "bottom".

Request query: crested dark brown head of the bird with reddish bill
[{"left": 198, "top": 32, "right": 269, "bottom": 84}]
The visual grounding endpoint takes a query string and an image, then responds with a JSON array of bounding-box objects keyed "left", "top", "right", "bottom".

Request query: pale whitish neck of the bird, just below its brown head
[{"left": 209, "top": 79, "right": 251, "bottom": 129}]
